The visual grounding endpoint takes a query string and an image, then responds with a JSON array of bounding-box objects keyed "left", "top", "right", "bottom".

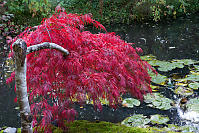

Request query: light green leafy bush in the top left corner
[{"left": 5, "top": 0, "right": 54, "bottom": 25}]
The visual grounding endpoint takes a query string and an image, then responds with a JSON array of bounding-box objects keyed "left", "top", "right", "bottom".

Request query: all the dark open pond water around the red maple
[{"left": 0, "top": 14, "right": 199, "bottom": 127}]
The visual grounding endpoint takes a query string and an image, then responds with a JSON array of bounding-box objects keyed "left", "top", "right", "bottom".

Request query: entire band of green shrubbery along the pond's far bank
[{"left": 4, "top": 0, "right": 199, "bottom": 24}]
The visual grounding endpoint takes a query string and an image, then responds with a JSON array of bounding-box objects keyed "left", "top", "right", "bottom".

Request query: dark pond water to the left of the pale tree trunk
[{"left": 0, "top": 40, "right": 20, "bottom": 127}]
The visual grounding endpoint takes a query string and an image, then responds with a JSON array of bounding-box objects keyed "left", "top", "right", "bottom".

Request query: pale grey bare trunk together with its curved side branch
[{"left": 12, "top": 39, "right": 69, "bottom": 133}]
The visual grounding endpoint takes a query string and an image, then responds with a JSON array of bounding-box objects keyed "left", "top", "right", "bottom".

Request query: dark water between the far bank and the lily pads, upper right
[{"left": 108, "top": 14, "right": 199, "bottom": 60}]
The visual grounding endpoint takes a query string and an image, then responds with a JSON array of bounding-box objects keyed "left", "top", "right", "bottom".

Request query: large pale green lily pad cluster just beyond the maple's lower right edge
[{"left": 144, "top": 93, "right": 173, "bottom": 110}]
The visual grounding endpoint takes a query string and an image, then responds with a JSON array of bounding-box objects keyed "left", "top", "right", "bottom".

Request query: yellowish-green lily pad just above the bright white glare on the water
[{"left": 174, "top": 86, "right": 193, "bottom": 96}]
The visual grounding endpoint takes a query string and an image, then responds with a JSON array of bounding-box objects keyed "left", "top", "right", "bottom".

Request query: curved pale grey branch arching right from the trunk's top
[{"left": 26, "top": 42, "right": 69, "bottom": 55}]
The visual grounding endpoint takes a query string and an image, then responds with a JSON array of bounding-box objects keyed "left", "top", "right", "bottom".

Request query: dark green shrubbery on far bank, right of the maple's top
[{"left": 60, "top": 0, "right": 199, "bottom": 24}]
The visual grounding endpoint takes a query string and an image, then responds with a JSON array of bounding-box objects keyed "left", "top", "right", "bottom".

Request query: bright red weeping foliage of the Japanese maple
[{"left": 8, "top": 12, "right": 155, "bottom": 130}]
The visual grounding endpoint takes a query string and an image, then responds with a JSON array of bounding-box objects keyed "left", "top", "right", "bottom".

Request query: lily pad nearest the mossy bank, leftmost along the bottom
[{"left": 121, "top": 114, "right": 151, "bottom": 127}]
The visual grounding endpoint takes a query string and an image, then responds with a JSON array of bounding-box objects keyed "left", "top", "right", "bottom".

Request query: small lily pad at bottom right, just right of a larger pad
[{"left": 151, "top": 114, "right": 169, "bottom": 124}]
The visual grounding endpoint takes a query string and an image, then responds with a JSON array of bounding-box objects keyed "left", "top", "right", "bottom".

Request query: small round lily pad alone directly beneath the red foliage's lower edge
[{"left": 122, "top": 98, "right": 140, "bottom": 108}]
